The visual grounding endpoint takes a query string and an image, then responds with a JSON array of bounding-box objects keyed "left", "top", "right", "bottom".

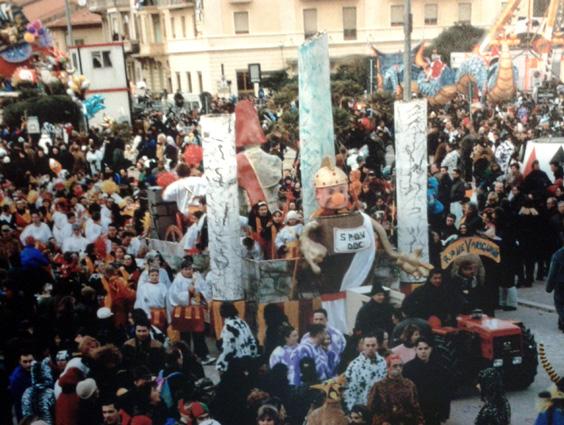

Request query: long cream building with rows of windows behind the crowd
[{"left": 88, "top": 0, "right": 540, "bottom": 96}]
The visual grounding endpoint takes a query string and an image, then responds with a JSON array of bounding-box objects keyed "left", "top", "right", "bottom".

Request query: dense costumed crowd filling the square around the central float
[{"left": 0, "top": 87, "right": 564, "bottom": 425}]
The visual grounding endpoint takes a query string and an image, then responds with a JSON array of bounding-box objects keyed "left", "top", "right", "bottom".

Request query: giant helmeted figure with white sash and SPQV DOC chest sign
[{"left": 300, "top": 158, "right": 432, "bottom": 294}]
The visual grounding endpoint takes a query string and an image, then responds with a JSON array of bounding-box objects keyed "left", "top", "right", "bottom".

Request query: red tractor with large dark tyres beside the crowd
[{"left": 432, "top": 310, "right": 538, "bottom": 389}]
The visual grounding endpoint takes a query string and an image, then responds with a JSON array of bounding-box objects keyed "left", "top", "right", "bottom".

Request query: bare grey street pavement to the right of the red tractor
[{"left": 447, "top": 282, "right": 564, "bottom": 425}]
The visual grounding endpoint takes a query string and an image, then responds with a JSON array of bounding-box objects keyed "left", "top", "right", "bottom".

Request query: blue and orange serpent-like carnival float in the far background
[{"left": 372, "top": 0, "right": 564, "bottom": 106}]
